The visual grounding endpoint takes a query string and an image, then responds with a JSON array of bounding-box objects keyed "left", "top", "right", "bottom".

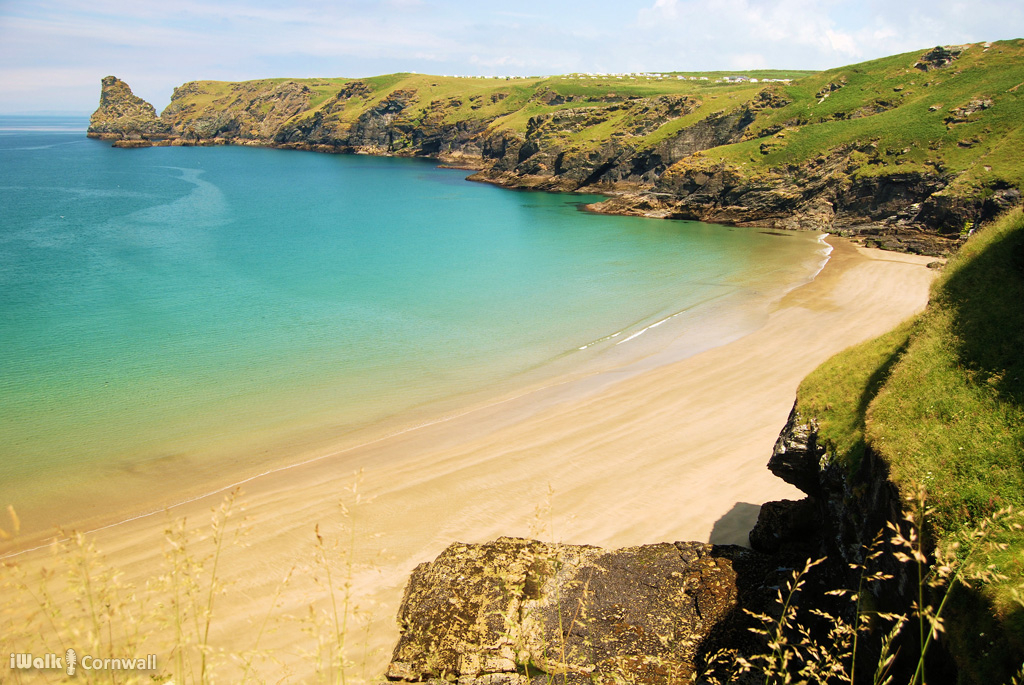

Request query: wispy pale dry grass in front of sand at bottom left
[{"left": 0, "top": 475, "right": 383, "bottom": 685}]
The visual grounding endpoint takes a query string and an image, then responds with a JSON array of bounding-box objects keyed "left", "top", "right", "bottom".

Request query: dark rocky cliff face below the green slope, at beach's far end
[{"left": 591, "top": 144, "right": 978, "bottom": 255}]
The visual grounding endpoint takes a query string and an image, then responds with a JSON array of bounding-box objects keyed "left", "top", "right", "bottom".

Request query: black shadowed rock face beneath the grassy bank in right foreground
[{"left": 750, "top": 409, "right": 1024, "bottom": 685}]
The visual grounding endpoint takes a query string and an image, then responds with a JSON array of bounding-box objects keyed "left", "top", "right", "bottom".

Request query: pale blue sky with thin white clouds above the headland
[{"left": 0, "top": 0, "right": 1024, "bottom": 114}]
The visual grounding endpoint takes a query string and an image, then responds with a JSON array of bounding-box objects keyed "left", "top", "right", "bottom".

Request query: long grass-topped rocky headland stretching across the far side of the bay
[{"left": 89, "top": 41, "right": 1024, "bottom": 254}]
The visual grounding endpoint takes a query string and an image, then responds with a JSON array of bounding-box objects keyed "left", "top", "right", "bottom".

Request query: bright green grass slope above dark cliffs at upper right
[{"left": 692, "top": 40, "right": 1024, "bottom": 202}]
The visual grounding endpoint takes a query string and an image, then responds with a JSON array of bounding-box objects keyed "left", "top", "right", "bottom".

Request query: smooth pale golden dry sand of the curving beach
[{"left": 4, "top": 239, "right": 935, "bottom": 682}]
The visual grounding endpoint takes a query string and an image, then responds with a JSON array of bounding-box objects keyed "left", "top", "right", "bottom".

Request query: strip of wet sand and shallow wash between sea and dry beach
[{"left": 0, "top": 215, "right": 831, "bottom": 548}]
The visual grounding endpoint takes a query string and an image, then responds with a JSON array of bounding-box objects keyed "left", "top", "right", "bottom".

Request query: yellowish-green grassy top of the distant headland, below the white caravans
[{"left": 157, "top": 72, "right": 798, "bottom": 142}]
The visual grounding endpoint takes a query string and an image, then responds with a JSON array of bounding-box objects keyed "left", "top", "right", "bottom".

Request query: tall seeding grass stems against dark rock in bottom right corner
[{"left": 705, "top": 494, "right": 1024, "bottom": 685}]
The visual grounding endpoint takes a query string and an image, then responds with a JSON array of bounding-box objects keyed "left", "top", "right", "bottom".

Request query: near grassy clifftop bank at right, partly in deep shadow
[{"left": 798, "top": 211, "right": 1024, "bottom": 682}]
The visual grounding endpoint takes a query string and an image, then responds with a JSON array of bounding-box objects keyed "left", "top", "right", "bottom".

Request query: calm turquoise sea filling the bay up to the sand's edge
[{"left": 0, "top": 117, "right": 826, "bottom": 532}]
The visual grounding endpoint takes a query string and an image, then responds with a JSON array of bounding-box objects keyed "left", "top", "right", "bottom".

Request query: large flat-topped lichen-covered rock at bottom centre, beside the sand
[{"left": 386, "top": 538, "right": 766, "bottom": 685}]
